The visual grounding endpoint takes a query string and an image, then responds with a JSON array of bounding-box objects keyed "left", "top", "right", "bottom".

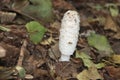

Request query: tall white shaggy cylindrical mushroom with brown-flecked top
[{"left": 59, "top": 10, "right": 80, "bottom": 61}]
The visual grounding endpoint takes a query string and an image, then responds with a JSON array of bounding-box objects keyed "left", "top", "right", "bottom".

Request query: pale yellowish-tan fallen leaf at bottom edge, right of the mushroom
[{"left": 77, "top": 67, "right": 103, "bottom": 80}]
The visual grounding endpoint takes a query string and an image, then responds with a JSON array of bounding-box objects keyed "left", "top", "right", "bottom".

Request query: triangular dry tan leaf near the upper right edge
[{"left": 104, "top": 16, "right": 118, "bottom": 32}]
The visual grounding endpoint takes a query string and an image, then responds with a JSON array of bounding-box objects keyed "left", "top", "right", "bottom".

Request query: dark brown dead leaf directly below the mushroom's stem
[{"left": 55, "top": 62, "right": 80, "bottom": 79}]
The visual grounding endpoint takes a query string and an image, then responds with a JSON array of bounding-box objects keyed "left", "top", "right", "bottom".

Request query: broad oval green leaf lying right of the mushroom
[{"left": 87, "top": 33, "right": 113, "bottom": 56}]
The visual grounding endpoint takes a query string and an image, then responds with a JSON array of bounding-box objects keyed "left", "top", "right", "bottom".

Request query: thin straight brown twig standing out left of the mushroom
[{"left": 17, "top": 40, "right": 27, "bottom": 66}]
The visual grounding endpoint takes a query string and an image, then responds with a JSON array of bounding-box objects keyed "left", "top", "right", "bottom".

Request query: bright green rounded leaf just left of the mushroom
[{"left": 25, "top": 21, "right": 46, "bottom": 44}]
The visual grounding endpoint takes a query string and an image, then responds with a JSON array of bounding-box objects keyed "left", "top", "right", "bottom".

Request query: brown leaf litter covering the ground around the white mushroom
[{"left": 0, "top": 0, "right": 120, "bottom": 80}]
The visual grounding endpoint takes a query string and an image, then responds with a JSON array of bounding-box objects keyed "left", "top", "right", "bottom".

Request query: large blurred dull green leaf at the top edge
[{"left": 22, "top": 0, "right": 53, "bottom": 22}]
